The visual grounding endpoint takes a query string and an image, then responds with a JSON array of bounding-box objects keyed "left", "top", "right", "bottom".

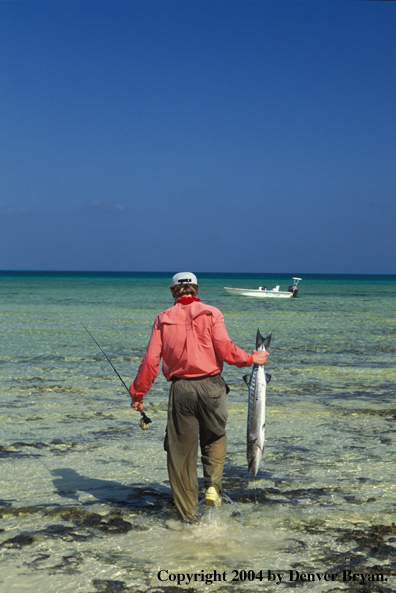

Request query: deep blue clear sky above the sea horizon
[{"left": 0, "top": 0, "right": 396, "bottom": 275}]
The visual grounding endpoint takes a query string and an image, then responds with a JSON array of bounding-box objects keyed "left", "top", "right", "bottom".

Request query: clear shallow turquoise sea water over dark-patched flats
[{"left": 0, "top": 272, "right": 396, "bottom": 593}]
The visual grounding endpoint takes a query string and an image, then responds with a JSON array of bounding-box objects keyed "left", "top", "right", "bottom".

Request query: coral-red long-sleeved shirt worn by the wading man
[{"left": 129, "top": 298, "right": 253, "bottom": 401}]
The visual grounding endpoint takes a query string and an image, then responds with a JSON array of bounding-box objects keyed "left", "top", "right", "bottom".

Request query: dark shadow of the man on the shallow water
[{"left": 51, "top": 468, "right": 173, "bottom": 511}]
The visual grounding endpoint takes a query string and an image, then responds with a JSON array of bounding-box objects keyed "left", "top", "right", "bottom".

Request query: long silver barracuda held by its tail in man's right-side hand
[{"left": 243, "top": 329, "right": 272, "bottom": 477}]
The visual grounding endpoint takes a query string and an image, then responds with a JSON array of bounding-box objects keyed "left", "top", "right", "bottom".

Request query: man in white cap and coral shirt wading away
[{"left": 129, "top": 272, "right": 268, "bottom": 522}]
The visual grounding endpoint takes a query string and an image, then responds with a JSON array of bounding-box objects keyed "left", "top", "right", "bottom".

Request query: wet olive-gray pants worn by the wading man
[{"left": 164, "top": 375, "right": 228, "bottom": 521}]
